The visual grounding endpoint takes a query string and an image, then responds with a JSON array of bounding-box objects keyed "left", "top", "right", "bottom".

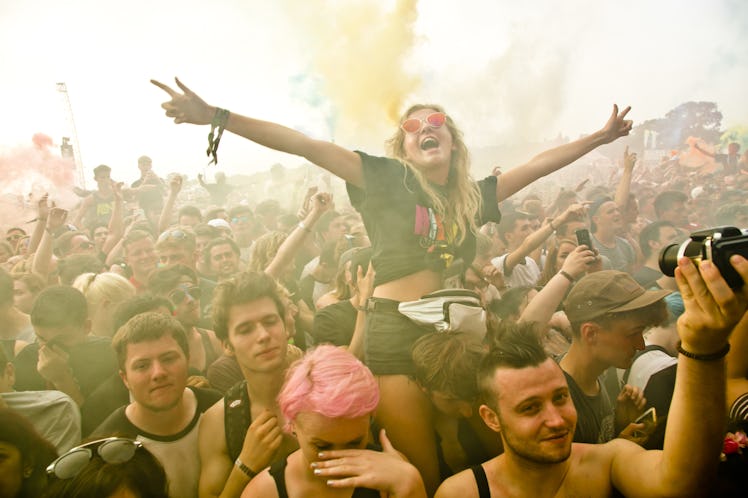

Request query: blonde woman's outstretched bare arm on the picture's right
[{"left": 496, "top": 105, "right": 633, "bottom": 202}]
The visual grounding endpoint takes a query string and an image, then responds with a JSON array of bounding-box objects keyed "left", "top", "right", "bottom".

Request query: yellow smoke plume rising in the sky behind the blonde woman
[{"left": 284, "top": 0, "right": 419, "bottom": 147}]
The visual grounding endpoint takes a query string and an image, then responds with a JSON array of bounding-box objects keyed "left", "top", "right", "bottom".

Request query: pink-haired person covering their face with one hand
[{"left": 242, "top": 345, "right": 426, "bottom": 498}]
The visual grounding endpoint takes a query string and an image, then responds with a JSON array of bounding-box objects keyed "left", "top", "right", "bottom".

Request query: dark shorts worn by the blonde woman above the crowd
[{"left": 364, "top": 297, "right": 434, "bottom": 375}]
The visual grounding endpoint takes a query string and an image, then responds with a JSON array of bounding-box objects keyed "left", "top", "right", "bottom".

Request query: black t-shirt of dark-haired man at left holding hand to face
[{"left": 13, "top": 335, "right": 118, "bottom": 397}]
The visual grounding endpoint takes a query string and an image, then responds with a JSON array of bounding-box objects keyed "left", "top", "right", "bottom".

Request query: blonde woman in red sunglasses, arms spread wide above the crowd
[{"left": 152, "top": 80, "right": 632, "bottom": 494}]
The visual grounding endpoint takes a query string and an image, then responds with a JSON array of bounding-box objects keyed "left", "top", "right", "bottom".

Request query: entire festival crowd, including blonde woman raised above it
[{"left": 0, "top": 80, "right": 748, "bottom": 498}]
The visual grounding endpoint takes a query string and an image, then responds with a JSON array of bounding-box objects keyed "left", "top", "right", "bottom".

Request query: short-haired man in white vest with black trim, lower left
[{"left": 94, "top": 312, "right": 221, "bottom": 498}]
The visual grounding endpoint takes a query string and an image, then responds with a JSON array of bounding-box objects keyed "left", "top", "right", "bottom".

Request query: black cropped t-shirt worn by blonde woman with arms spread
[{"left": 346, "top": 152, "right": 501, "bottom": 286}]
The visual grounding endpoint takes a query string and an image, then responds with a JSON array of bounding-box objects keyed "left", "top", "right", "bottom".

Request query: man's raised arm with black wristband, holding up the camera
[{"left": 612, "top": 255, "right": 748, "bottom": 496}]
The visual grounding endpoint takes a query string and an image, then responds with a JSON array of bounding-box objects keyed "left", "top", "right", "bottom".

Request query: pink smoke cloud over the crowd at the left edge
[{"left": 0, "top": 133, "right": 78, "bottom": 232}]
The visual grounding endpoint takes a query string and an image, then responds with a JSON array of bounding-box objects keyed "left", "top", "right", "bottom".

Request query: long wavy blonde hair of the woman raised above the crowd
[{"left": 385, "top": 104, "right": 481, "bottom": 245}]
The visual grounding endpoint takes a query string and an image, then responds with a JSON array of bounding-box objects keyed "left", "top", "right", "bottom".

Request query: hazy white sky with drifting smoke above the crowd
[{"left": 0, "top": 0, "right": 748, "bottom": 185}]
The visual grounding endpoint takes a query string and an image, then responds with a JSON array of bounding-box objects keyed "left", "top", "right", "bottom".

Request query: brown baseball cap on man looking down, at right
[{"left": 564, "top": 270, "right": 671, "bottom": 323}]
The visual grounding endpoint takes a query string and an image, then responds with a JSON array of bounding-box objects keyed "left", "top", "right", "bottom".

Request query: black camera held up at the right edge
[{"left": 660, "top": 227, "right": 748, "bottom": 289}]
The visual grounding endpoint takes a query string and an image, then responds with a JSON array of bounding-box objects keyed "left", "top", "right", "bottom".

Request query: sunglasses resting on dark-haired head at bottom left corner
[{"left": 47, "top": 437, "right": 143, "bottom": 479}]
